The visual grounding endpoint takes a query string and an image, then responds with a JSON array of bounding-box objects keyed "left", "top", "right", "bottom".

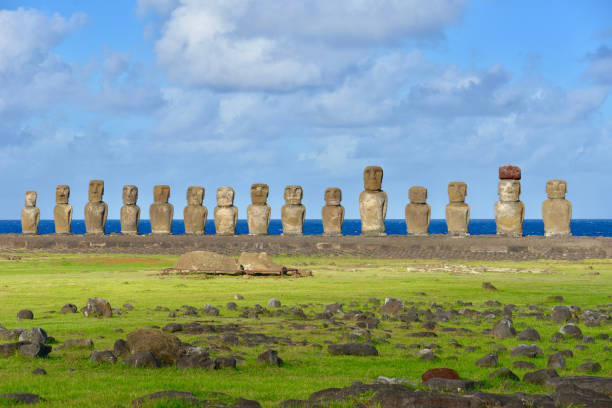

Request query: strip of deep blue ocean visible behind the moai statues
[{"left": 0, "top": 220, "right": 612, "bottom": 237}]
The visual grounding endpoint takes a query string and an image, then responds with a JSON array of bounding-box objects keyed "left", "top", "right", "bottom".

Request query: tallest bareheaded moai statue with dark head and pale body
[{"left": 359, "top": 166, "right": 389, "bottom": 236}]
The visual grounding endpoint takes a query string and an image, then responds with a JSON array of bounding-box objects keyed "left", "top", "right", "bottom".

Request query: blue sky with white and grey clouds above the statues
[{"left": 0, "top": 0, "right": 612, "bottom": 219}]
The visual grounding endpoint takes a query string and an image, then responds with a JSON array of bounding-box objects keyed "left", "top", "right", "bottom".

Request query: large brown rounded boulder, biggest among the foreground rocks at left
[{"left": 126, "top": 328, "right": 181, "bottom": 364}]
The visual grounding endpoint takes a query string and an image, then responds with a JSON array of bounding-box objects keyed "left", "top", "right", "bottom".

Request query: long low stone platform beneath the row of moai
[{"left": 0, "top": 234, "right": 612, "bottom": 260}]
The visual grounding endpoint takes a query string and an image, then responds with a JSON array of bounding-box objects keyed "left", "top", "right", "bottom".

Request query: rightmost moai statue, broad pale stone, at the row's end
[{"left": 542, "top": 180, "right": 572, "bottom": 237}]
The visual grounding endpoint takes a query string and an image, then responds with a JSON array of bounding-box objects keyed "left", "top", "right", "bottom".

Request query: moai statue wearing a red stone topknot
[{"left": 495, "top": 166, "right": 525, "bottom": 237}]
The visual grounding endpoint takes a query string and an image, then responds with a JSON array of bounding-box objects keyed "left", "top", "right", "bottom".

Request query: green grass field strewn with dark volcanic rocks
[{"left": 0, "top": 253, "right": 612, "bottom": 407}]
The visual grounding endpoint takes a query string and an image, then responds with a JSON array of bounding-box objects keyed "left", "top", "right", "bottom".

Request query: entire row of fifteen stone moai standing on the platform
[{"left": 21, "top": 165, "right": 572, "bottom": 237}]
